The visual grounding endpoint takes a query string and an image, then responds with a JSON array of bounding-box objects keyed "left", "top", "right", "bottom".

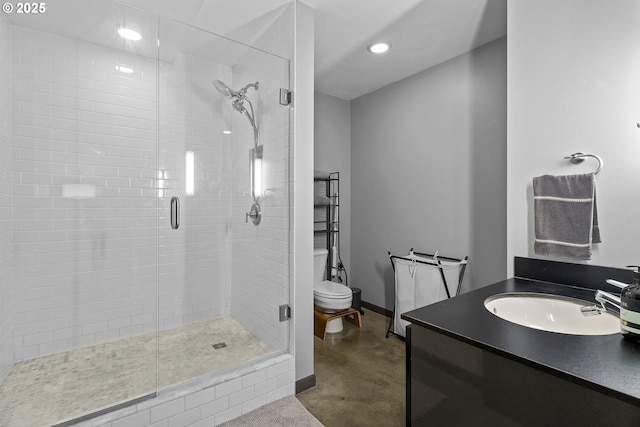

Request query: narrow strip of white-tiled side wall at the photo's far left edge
[{"left": 0, "top": 16, "right": 14, "bottom": 384}]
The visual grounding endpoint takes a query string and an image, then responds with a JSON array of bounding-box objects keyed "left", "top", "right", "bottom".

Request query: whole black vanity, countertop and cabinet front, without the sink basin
[{"left": 402, "top": 261, "right": 640, "bottom": 427}]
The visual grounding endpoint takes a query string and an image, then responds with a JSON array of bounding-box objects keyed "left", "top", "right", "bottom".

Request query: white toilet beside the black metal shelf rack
[{"left": 313, "top": 249, "right": 353, "bottom": 333}]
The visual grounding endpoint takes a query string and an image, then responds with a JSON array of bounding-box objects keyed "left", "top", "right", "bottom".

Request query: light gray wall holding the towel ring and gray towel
[{"left": 508, "top": 0, "right": 640, "bottom": 278}]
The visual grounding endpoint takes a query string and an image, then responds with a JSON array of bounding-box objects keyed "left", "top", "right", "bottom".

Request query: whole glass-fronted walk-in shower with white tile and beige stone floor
[{"left": 0, "top": 0, "right": 290, "bottom": 426}]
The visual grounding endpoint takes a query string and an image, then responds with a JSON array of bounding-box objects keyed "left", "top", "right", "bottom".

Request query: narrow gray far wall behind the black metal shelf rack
[{"left": 314, "top": 92, "right": 351, "bottom": 274}]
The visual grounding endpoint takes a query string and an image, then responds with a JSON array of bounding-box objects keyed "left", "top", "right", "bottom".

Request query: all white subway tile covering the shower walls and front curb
[{"left": 0, "top": 6, "right": 295, "bottom": 426}]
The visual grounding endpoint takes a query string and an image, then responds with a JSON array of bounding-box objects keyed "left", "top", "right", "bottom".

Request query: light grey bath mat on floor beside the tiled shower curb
[{"left": 220, "top": 396, "right": 322, "bottom": 427}]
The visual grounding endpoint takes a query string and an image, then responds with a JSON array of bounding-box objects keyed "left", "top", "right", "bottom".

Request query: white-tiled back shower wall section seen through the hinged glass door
[{"left": 159, "top": 53, "right": 231, "bottom": 332}]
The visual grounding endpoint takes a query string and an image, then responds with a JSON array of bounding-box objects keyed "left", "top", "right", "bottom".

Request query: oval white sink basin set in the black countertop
[{"left": 484, "top": 292, "right": 620, "bottom": 335}]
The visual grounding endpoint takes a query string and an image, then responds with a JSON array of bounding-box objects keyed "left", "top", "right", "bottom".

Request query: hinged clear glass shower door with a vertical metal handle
[{"left": 157, "top": 19, "right": 290, "bottom": 388}]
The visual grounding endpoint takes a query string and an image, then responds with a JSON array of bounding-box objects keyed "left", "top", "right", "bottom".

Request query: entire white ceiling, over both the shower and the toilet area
[{"left": 9, "top": 0, "right": 507, "bottom": 100}]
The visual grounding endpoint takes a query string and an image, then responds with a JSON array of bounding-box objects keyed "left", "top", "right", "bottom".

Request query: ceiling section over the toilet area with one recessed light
[{"left": 302, "top": 0, "right": 507, "bottom": 100}]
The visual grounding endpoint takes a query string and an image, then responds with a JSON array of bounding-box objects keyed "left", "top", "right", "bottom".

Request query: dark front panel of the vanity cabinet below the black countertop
[{"left": 407, "top": 325, "right": 640, "bottom": 427}]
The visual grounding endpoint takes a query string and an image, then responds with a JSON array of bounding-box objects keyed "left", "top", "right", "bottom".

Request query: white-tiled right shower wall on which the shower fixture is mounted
[{"left": 231, "top": 58, "right": 290, "bottom": 349}]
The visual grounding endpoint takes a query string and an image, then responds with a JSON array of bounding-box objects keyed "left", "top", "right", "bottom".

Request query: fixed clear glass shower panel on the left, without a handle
[{"left": 0, "top": 0, "right": 157, "bottom": 426}]
